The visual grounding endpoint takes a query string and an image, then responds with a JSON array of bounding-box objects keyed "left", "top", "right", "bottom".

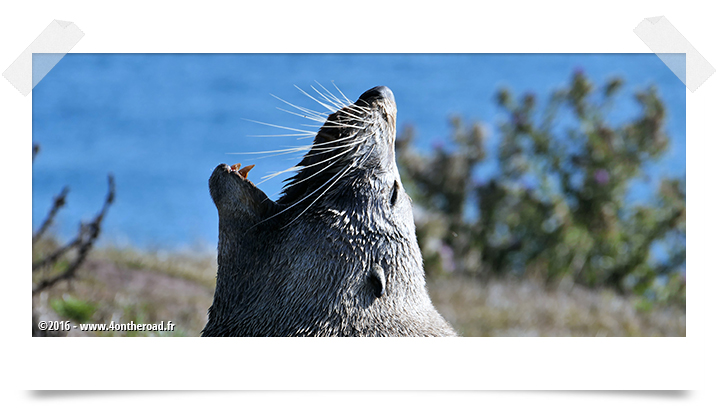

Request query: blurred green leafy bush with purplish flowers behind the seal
[{"left": 397, "top": 71, "right": 685, "bottom": 306}]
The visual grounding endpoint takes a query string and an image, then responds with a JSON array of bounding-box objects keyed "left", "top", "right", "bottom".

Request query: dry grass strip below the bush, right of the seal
[{"left": 429, "top": 279, "right": 685, "bottom": 337}]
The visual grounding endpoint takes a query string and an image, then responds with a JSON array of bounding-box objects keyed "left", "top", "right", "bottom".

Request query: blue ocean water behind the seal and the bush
[{"left": 28, "top": 54, "right": 685, "bottom": 249}]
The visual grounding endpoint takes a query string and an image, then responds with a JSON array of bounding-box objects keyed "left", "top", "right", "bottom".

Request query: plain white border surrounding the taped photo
[{"left": 0, "top": 0, "right": 720, "bottom": 419}]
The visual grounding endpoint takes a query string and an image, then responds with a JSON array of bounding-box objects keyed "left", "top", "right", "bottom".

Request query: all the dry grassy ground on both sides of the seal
[{"left": 33, "top": 244, "right": 685, "bottom": 336}]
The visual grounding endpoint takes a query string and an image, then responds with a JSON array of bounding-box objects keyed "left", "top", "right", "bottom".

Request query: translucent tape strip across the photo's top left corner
[{"left": 3, "top": 20, "right": 85, "bottom": 96}]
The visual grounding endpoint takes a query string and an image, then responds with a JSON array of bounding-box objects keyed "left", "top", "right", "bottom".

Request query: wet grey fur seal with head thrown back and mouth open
[{"left": 202, "top": 86, "right": 457, "bottom": 336}]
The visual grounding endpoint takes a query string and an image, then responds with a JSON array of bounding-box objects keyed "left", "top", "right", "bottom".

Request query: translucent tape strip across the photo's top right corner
[{"left": 633, "top": 16, "right": 715, "bottom": 92}]
